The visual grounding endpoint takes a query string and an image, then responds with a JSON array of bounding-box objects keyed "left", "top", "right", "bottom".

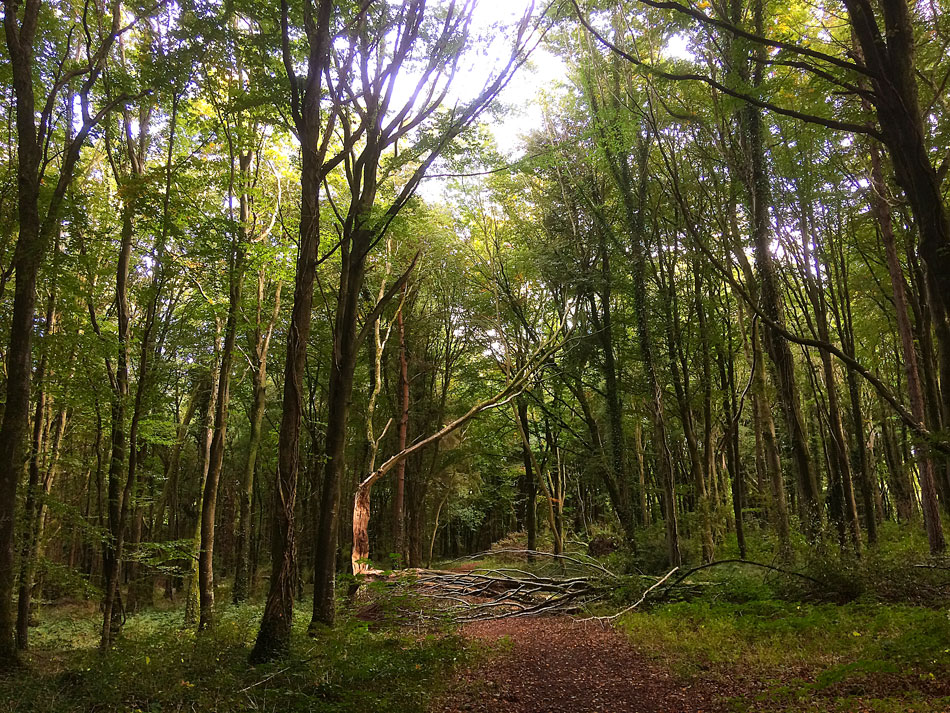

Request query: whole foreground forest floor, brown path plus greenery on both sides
[{"left": 0, "top": 560, "right": 950, "bottom": 713}]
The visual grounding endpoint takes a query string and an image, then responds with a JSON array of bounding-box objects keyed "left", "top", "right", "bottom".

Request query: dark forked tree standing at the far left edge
[{"left": 0, "top": 0, "right": 126, "bottom": 666}]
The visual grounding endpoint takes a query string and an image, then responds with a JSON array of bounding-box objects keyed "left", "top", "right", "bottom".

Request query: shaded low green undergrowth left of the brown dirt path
[{"left": 0, "top": 606, "right": 464, "bottom": 713}]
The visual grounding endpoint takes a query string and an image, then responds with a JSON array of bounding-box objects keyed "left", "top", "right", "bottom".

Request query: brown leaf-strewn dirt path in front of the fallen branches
[{"left": 433, "top": 616, "right": 722, "bottom": 713}]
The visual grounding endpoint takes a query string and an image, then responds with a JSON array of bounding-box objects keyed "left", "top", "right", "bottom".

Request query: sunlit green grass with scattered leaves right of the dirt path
[{"left": 622, "top": 599, "right": 950, "bottom": 712}]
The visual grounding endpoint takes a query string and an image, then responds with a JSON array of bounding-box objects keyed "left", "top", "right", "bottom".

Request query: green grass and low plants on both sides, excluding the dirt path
[{"left": 0, "top": 548, "right": 950, "bottom": 713}]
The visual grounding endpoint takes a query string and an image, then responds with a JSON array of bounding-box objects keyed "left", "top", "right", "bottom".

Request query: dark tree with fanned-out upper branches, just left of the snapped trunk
[{"left": 311, "top": 0, "right": 531, "bottom": 631}]
